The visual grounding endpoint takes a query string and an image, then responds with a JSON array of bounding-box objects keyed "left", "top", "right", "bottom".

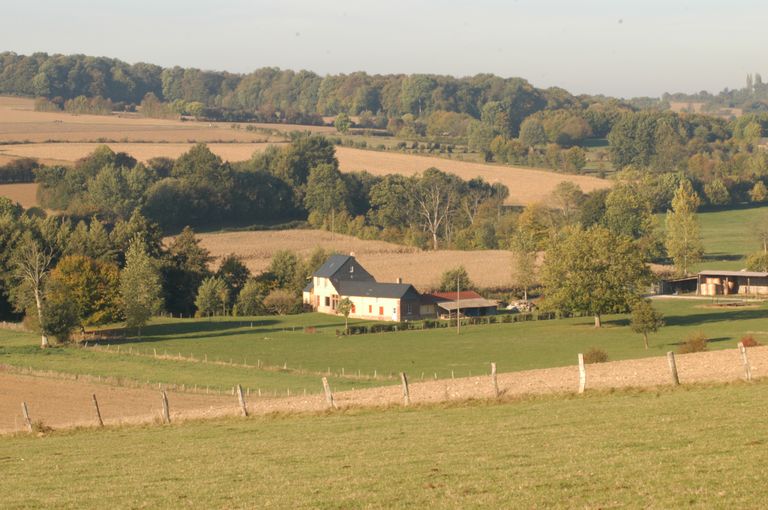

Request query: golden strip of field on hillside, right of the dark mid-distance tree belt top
[{"left": 336, "top": 147, "right": 611, "bottom": 205}]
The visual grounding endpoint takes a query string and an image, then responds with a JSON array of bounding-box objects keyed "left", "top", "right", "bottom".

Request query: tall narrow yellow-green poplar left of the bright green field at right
[{"left": 665, "top": 180, "right": 704, "bottom": 276}]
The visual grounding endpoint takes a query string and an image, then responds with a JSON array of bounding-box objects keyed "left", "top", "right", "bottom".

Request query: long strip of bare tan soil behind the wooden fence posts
[{"left": 0, "top": 346, "right": 768, "bottom": 432}]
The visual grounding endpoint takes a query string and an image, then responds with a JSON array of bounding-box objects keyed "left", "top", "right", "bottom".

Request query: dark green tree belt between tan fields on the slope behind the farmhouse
[{"left": 31, "top": 137, "right": 508, "bottom": 249}]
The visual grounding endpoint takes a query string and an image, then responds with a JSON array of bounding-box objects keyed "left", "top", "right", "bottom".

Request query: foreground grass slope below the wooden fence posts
[{"left": 0, "top": 381, "right": 768, "bottom": 509}]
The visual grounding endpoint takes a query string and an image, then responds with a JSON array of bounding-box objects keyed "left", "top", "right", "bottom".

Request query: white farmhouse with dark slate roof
[{"left": 303, "top": 255, "right": 420, "bottom": 322}]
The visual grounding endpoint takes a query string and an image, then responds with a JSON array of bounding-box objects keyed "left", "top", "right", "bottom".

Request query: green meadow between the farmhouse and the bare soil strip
[{"left": 0, "top": 299, "right": 768, "bottom": 392}]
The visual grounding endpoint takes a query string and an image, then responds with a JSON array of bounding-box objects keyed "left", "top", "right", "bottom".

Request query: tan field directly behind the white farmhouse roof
[{"left": 183, "top": 230, "right": 512, "bottom": 290}]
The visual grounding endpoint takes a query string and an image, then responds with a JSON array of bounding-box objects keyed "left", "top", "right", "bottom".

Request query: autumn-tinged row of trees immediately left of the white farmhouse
[{"left": 0, "top": 190, "right": 336, "bottom": 346}]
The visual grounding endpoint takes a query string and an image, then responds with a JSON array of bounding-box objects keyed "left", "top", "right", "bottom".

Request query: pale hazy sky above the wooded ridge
[{"left": 0, "top": 0, "right": 768, "bottom": 97}]
